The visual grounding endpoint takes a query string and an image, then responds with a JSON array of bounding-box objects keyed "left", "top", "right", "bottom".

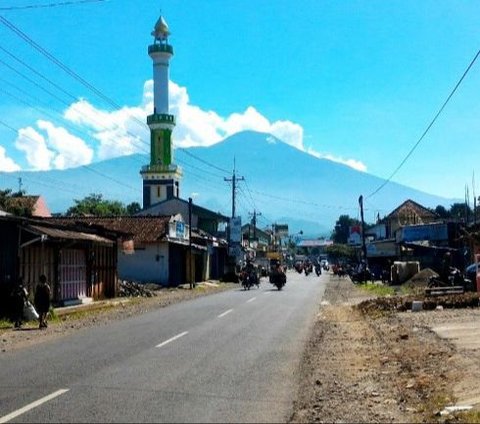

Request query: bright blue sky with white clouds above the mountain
[{"left": 0, "top": 0, "right": 480, "bottom": 204}]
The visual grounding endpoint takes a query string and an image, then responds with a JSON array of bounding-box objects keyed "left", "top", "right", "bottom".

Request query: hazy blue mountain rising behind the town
[{"left": 1, "top": 131, "right": 459, "bottom": 237}]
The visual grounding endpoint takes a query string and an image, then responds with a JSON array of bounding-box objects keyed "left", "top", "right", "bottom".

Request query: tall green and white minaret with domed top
[{"left": 140, "top": 16, "right": 182, "bottom": 209}]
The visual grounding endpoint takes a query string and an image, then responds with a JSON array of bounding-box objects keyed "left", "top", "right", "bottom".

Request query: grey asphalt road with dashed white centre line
[{"left": 0, "top": 271, "right": 328, "bottom": 423}]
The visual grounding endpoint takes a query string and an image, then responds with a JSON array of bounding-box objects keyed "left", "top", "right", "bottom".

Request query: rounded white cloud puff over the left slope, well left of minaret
[{"left": 15, "top": 120, "right": 93, "bottom": 170}]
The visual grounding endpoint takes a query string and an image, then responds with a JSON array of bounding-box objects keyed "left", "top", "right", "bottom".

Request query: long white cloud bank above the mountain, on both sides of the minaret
[{"left": 9, "top": 80, "right": 366, "bottom": 171}]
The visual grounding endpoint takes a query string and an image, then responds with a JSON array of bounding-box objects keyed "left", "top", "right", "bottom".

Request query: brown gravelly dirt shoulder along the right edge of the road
[{"left": 290, "top": 276, "right": 480, "bottom": 423}]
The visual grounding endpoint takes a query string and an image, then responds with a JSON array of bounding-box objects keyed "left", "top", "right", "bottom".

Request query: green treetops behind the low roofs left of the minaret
[{"left": 66, "top": 193, "right": 141, "bottom": 216}]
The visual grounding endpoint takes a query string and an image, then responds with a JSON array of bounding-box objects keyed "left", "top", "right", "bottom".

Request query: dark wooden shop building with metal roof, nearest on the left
[{"left": 0, "top": 216, "right": 119, "bottom": 315}]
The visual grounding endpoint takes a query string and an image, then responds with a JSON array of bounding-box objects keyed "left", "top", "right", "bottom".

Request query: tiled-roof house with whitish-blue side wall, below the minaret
[{"left": 47, "top": 214, "right": 227, "bottom": 286}]
